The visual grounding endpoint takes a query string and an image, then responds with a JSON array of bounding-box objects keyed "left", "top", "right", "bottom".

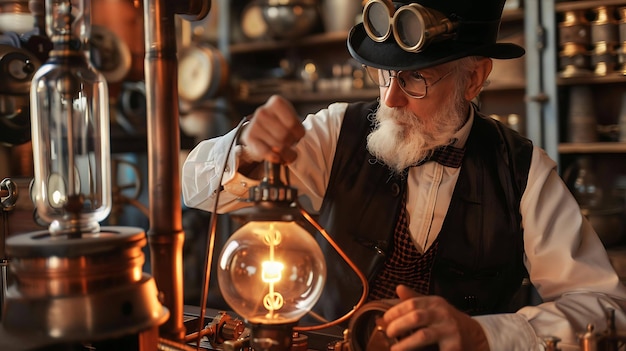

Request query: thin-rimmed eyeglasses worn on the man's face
[{"left": 363, "top": 65, "right": 454, "bottom": 99}]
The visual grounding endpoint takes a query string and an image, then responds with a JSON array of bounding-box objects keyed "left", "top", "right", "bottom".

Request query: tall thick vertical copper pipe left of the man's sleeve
[{"left": 144, "top": 0, "right": 211, "bottom": 340}]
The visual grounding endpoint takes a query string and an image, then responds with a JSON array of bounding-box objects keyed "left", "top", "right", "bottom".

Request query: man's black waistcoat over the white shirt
[{"left": 314, "top": 102, "right": 532, "bottom": 319}]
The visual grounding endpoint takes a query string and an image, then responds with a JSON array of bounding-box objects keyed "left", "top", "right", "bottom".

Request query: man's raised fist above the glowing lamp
[{"left": 239, "top": 95, "right": 304, "bottom": 163}]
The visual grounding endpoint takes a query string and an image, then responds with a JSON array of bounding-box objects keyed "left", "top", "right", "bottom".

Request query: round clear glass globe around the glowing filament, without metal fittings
[{"left": 217, "top": 221, "right": 326, "bottom": 324}]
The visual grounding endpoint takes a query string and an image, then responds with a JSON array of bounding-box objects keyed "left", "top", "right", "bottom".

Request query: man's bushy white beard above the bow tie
[{"left": 367, "top": 88, "right": 467, "bottom": 174}]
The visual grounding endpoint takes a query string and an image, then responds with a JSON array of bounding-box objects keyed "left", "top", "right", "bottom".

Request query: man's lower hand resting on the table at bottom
[{"left": 383, "top": 285, "right": 489, "bottom": 351}]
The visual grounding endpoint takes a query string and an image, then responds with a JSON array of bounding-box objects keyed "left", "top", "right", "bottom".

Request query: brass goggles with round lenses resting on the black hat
[{"left": 363, "top": 0, "right": 458, "bottom": 52}]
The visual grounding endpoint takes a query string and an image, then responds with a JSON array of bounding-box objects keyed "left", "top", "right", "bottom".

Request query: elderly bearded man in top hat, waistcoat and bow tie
[{"left": 183, "top": 0, "right": 626, "bottom": 351}]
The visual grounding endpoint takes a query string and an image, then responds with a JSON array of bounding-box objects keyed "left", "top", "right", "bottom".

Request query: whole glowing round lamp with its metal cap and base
[{"left": 217, "top": 161, "right": 326, "bottom": 351}]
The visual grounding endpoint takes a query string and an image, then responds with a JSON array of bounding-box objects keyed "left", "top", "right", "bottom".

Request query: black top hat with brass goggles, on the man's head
[{"left": 348, "top": 0, "right": 524, "bottom": 70}]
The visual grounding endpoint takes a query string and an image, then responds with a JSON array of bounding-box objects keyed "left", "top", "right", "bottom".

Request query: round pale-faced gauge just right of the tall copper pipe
[{"left": 178, "top": 44, "right": 228, "bottom": 102}]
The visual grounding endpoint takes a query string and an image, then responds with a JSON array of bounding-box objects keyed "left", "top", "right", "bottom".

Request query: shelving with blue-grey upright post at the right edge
[{"left": 525, "top": 0, "right": 626, "bottom": 253}]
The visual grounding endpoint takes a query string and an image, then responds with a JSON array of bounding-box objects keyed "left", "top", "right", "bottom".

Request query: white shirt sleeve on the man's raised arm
[{"left": 181, "top": 103, "right": 348, "bottom": 213}]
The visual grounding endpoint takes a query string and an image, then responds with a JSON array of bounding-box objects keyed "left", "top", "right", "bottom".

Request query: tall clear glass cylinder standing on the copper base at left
[{"left": 30, "top": 0, "right": 111, "bottom": 238}]
